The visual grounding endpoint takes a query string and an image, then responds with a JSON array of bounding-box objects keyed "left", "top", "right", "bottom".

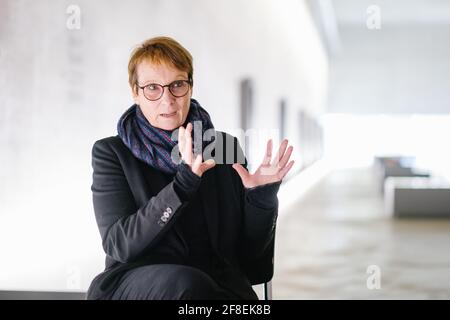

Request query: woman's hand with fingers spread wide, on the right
[{"left": 233, "top": 139, "right": 294, "bottom": 188}]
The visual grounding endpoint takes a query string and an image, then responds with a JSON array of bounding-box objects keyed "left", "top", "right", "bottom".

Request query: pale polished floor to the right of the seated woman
[{"left": 273, "top": 168, "right": 450, "bottom": 299}]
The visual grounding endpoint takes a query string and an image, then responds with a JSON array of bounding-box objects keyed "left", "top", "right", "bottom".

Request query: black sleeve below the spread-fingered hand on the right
[{"left": 232, "top": 139, "right": 281, "bottom": 260}]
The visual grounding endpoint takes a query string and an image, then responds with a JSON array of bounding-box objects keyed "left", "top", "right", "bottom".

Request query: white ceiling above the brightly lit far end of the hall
[{"left": 326, "top": 0, "right": 450, "bottom": 114}]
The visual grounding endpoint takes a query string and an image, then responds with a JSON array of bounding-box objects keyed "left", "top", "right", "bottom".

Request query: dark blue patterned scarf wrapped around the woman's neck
[{"left": 117, "top": 99, "right": 214, "bottom": 174}]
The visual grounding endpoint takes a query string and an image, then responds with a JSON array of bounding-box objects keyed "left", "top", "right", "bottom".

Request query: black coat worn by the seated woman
[{"left": 87, "top": 131, "right": 278, "bottom": 299}]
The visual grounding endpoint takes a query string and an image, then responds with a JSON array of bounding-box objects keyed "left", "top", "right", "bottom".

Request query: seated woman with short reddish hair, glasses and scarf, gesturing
[{"left": 87, "top": 37, "right": 293, "bottom": 299}]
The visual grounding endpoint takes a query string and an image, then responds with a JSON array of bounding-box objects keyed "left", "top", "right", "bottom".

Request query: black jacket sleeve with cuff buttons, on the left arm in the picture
[{"left": 91, "top": 140, "right": 201, "bottom": 263}]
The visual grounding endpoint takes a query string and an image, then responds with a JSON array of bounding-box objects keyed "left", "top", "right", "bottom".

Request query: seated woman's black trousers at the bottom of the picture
[{"left": 111, "top": 264, "right": 236, "bottom": 300}]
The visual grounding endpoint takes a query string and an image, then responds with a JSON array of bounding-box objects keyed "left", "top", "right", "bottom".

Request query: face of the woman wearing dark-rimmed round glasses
[{"left": 133, "top": 61, "right": 192, "bottom": 131}]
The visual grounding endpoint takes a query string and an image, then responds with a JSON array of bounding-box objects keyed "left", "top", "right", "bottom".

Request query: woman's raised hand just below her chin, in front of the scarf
[{"left": 178, "top": 123, "right": 216, "bottom": 177}]
